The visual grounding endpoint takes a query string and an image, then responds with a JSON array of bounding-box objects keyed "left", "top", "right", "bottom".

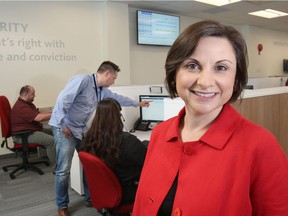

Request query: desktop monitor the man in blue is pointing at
[{"left": 139, "top": 95, "right": 169, "bottom": 122}]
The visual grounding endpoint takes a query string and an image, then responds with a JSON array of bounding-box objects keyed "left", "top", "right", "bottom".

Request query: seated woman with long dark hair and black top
[{"left": 81, "top": 98, "right": 147, "bottom": 204}]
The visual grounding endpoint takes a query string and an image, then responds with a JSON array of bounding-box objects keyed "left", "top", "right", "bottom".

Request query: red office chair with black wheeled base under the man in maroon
[{"left": 0, "top": 96, "right": 49, "bottom": 179}]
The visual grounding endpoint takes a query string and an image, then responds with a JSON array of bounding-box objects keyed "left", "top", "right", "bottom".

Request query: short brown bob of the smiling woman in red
[{"left": 165, "top": 20, "right": 248, "bottom": 102}]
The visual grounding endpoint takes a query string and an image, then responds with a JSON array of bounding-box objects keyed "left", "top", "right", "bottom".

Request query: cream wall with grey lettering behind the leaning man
[{"left": 0, "top": 2, "right": 130, "bottom": 107}]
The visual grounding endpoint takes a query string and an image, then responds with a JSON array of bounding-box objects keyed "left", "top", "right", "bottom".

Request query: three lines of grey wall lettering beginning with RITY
[{"left": 0, "top": 22, "right": 77, "bottom": 62}]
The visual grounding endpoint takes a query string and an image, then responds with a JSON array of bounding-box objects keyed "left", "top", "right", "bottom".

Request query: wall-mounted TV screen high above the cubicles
[{"left": 137, "top": 10, "right": 180, "bottom": 46}]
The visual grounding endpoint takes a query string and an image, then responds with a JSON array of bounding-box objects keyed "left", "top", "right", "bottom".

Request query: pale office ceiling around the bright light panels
[{"left": 116, "top": 0, "right": 288, "bottom": 32}]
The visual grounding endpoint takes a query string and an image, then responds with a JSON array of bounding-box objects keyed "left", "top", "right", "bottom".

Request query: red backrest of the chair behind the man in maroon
[{"left": 0, "top": 95, "right": 11, "bottom": 138}]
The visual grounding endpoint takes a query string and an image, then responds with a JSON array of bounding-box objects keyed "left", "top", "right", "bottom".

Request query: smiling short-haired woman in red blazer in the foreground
[{"left": 133, "top": 20, "right": 288, "bottom": 216}]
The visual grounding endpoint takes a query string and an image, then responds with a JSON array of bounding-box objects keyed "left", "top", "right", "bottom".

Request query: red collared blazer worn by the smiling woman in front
[{"left": 133, "top": 104, "right": 288, "bottom": 216}]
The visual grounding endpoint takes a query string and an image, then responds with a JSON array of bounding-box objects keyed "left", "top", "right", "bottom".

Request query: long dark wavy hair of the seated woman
[{"left": 81, "top": 98, "right": 123, "bottom": 166}]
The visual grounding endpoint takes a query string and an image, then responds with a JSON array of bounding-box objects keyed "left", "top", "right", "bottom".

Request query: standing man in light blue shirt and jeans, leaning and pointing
[{"left": 49, "top": 61, "right": 149, "bottom": 216}]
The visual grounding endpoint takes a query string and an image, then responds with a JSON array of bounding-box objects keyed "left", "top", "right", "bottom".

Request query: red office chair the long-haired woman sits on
[{"left": 78, "top": 151, "right": 133, "bottom": 216}]
